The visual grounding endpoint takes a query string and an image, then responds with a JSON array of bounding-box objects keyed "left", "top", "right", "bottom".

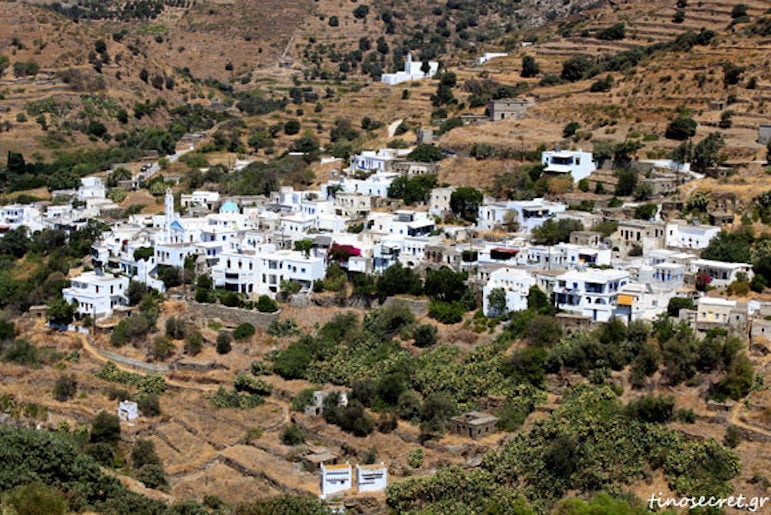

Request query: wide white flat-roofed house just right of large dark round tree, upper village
[{"left": 477, "top": 198, "right": 567, "bottom": 232}]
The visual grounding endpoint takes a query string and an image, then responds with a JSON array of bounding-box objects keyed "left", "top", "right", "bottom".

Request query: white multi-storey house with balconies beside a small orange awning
[{"left": 553, "top": 269, "right": 629, "bottom": 322}]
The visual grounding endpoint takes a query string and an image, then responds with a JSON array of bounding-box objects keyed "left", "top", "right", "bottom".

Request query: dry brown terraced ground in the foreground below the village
[{"left": 0, "top": 301, "right": 771, "bottom": 508}]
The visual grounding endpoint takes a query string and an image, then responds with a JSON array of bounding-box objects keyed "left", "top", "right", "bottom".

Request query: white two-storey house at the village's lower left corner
[{"left": 62, "top": 271, "right": 129, "bottom": 319}]
